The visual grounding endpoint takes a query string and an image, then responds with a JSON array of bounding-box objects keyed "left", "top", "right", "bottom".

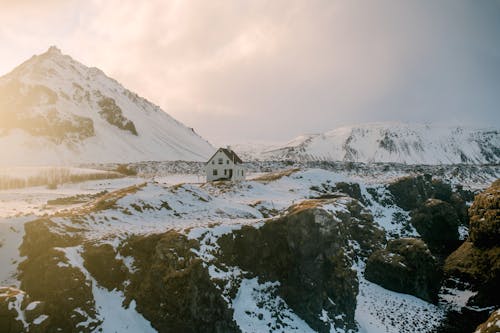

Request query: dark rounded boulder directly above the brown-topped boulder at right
[{"left": 410, "top": 199, "right": 460, "bottom": 255}]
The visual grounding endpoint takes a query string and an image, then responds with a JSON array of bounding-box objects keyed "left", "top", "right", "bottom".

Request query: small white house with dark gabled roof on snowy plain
[{"left": 206, "top": 147, "right": 246, "bottom": 182}]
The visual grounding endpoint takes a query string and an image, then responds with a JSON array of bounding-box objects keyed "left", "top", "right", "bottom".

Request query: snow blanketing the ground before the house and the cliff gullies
[{"left": 0, "top": 169, "right": 492, "bottom": 333}]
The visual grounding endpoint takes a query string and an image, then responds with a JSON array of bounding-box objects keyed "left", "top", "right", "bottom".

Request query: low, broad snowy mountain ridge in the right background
[{"left": 258, "top": 123, "right": 500, "bottom": 164}]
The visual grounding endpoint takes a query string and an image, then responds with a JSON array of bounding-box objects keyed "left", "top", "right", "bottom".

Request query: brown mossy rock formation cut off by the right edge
[{"left": 438, "top": 180, "right": 500, "bottom": 333}]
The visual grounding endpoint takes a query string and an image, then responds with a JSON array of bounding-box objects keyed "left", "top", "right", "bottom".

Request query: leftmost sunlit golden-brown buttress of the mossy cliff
[{"left": 19, "top": 219, "right": 99, "bottom": 332}]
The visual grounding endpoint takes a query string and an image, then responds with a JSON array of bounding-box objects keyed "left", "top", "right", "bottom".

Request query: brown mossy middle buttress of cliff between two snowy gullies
[{"left": 122, "top": 231, "right": 239, "bottom": 333}]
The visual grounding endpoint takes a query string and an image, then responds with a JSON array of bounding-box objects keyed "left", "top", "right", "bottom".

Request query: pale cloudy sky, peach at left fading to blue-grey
[{"left": 0, "top": 0, "right": 500, "bottom": 144}]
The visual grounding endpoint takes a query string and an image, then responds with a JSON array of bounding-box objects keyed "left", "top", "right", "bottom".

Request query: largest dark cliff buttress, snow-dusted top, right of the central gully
[{"left": 218, "top": 198, "right": 384, "bottom": 332}]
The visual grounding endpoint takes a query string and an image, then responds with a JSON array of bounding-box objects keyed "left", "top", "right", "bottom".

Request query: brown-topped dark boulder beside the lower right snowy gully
[{"left": 365, "top": 238, "right": 442, "bottom": 302}]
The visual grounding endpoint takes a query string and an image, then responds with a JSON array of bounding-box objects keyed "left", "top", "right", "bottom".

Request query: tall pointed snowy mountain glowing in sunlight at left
[{"left": 0, "top": 47, "right": 214, "bottom": 165}]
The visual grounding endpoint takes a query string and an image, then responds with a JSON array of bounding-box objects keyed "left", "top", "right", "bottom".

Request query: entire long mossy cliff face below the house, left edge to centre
[{"left": 11, "top": 196, "right": 385, "bottom": 333}]
